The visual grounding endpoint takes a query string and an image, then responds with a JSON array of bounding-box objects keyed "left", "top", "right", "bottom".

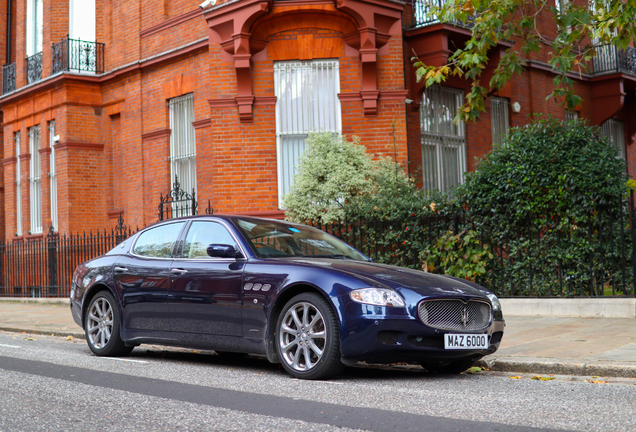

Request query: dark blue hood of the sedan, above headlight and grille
[{"left": 286, "top": 258, "right": 487, "bottom": 298}]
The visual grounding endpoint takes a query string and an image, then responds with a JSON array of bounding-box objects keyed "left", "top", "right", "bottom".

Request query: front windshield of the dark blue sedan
[{"left": 233, "top": 218, "right": 369, "bottom": 261}]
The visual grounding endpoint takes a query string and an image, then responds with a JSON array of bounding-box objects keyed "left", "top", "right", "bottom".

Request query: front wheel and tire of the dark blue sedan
[{"left": 276, "top": 293, "right": 344, "bottom": 379}]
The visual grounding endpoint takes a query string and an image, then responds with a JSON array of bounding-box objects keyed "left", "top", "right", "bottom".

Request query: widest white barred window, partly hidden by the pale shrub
[{"left": 274, "top": 59, "right": 342, "bottom": 208}]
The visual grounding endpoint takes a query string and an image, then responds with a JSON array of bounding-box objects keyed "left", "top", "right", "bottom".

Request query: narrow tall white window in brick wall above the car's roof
[{"left": 168, "top": 93, "right": 197, "bottom": 206}]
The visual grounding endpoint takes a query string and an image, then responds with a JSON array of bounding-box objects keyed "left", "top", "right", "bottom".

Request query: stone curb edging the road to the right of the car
[{"left": 475, "top": 357, "right": 636, "bottom": 378}]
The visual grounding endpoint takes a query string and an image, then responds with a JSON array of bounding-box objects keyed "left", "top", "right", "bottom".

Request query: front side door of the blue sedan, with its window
[{"left": 168, "top": 220, "right": 245, "bottom": 336}]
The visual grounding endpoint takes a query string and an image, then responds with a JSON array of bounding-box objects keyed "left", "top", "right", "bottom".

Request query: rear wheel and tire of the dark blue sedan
[{"left": 84, "top": 291, "right": 134, "bottom": 357}]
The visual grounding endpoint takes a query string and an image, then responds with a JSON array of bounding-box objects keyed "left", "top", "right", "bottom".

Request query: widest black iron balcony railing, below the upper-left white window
[{"left": 51, "top": 37, "right": 104, "bottom": 74}]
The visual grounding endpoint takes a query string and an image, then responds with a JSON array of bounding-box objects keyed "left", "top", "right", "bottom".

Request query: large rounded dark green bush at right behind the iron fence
[{"left": 459, "top": 119, "right": 631, "bottom": 295}]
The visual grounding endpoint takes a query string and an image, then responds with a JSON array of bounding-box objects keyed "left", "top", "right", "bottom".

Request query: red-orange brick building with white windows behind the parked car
[{"left": 0, "top": 0, "right": 636, "bottom": 241}]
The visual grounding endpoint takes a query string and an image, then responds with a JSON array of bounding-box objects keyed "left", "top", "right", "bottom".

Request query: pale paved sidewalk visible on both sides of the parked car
[{"left": 0, "top": 299, "right": 636, "bottom": 378}]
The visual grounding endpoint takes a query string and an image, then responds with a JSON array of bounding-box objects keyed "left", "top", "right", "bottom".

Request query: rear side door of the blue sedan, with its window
[{"left": 113, "top": 221, "right": 185, "bottom": 331}]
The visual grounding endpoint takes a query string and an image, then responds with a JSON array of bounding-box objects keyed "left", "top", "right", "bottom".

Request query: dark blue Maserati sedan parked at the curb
[{"left": 71, "top": 215, "right": 504, "bottom": 379}]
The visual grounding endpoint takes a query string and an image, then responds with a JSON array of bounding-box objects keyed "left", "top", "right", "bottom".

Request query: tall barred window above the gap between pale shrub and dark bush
[{"left": 420, "top": 85, "right": 466, "bottom": 191}]
